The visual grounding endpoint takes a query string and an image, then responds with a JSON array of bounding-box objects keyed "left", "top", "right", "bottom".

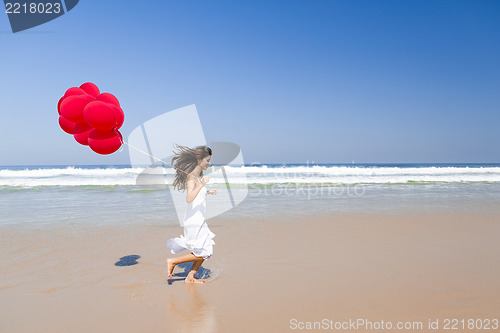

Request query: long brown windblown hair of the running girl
[{"left": 171, "top": 144, "right": 212, "bottom": 191}]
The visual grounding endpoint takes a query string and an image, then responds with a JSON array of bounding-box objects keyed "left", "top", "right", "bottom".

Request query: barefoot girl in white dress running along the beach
[{"left": 167, "top": 145, "right": 217, "bottom": 283}]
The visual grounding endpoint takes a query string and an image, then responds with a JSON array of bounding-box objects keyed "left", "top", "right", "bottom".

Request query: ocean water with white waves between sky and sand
[{"left": 0, "top": 163, "right": 500, "bottom": 227}]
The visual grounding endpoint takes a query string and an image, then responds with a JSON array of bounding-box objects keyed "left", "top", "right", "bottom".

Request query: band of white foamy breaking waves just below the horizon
[{"left": 0, "top": 165, "right": 500, "bottom": 187}]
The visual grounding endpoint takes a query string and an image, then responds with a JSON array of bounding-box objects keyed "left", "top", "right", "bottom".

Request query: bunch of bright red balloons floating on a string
[{"left": 57, "top": 82, "right": 125, "bottom": 155}]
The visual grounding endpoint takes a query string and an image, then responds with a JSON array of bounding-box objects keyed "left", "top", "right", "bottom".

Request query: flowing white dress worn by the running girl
[{"left": 167, "top": 186, "right": 215, "bottom": 259}]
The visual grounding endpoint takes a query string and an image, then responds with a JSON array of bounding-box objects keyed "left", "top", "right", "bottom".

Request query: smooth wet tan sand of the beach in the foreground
[{"left": 0, "top": 213, "right": 500, "bottom": 332}]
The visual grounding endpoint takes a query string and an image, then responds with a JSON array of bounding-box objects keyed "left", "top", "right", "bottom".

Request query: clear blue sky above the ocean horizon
[{"left": 0, "top": 0, "right": 500, "bottom": 165}]
